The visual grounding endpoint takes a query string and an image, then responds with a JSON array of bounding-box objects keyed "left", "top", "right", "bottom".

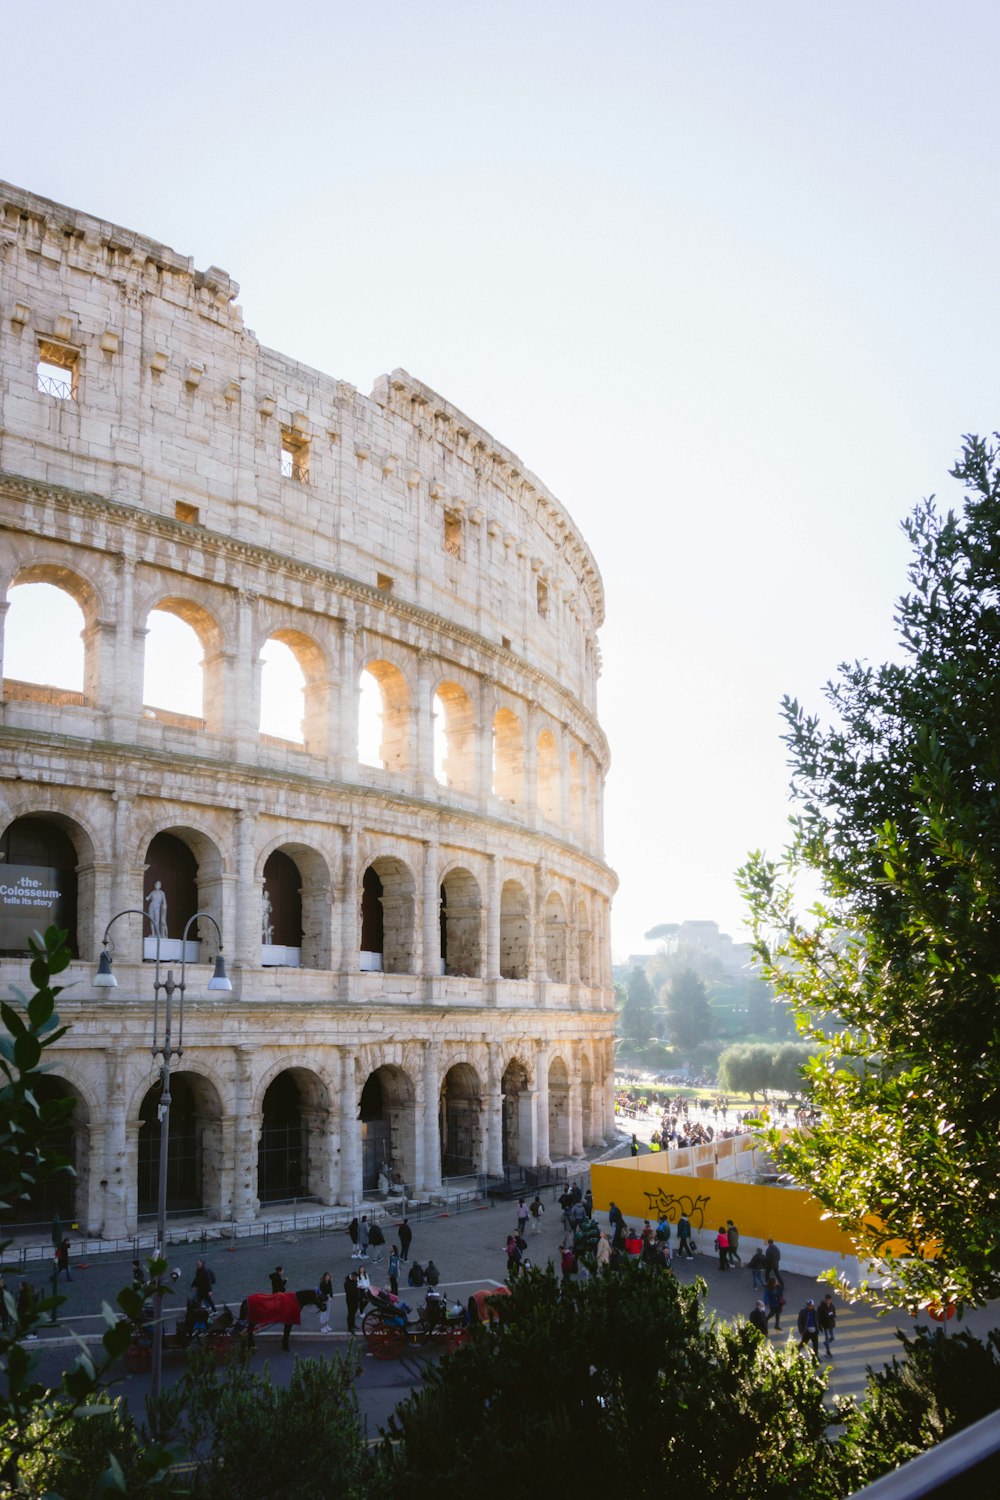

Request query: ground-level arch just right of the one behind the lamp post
[{"left": 256, "top": 1065, "right": 330, "bottom": 1203}]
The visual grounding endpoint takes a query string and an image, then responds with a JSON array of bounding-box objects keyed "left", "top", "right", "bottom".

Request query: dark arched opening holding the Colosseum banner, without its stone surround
[{"left": 0, "top": 818, "right": 79, "bottom": 957}]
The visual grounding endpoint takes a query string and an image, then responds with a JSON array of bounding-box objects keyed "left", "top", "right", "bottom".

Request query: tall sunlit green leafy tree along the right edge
[{"left": 741, "top": 438, "right": 1000, "bottom": 1305}]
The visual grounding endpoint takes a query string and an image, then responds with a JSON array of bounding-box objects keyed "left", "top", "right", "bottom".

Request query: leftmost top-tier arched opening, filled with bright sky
[{"left": 3, "top": 582, "right": 87, "bottom": 707}]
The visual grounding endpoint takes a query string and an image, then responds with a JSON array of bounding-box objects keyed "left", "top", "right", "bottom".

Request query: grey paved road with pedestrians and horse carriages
[{"left": 7, "top": 1176, "right": 1000, "bottom": 1434}]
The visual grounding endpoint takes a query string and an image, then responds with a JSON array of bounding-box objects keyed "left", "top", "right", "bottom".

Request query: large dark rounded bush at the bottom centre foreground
[{"left": 372, "top": 1266, "right": 831, "bottom": 1500}]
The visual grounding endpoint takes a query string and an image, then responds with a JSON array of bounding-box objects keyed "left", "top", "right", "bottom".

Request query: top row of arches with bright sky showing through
[{"left": 1, "top": 564, "right": 601, "bottom": 842}]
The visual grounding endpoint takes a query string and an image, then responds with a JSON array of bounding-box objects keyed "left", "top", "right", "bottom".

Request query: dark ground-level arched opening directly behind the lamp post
[{"left": 136, "top": 1073, "right": 222, "bottom": 1217}]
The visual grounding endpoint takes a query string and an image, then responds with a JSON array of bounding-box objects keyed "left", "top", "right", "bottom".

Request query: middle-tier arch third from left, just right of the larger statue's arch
[{"left": 259, "top": 840, "right": 333, "bottom": 969}]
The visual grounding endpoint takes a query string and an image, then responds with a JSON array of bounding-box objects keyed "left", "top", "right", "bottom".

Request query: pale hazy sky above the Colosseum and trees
[{"left": 0, "top": 0, "right": 1000, "bottom": 956}]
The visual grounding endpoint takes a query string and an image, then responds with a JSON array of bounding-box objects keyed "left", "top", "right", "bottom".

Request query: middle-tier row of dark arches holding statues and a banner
[{"left": 0, "top": 813, "right": 603, "bottom": 986}]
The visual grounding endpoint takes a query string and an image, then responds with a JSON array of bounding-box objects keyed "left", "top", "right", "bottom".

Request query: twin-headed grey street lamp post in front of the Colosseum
[{"left": 93, "top": 908, "right": 232, "bottom": 1403}]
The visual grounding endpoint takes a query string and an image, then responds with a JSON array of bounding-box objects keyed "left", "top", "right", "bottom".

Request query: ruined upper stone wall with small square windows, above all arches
[{"left": 0, "top": 183, "right": 604, "bottom": 708}]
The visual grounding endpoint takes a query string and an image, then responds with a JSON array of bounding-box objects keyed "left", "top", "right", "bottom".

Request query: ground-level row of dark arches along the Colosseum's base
[{"left": 12, "top": 1053, "right": 604, "bottom": 1233}]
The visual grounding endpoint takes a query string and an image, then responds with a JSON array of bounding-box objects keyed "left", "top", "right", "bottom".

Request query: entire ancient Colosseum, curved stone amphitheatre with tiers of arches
[{"left": 0, "top": 185, "right": 615, "bottom": 1236}]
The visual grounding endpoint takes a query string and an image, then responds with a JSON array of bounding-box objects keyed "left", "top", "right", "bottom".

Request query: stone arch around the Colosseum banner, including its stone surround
[{"left": 0, "top": 809, "right": 96, "bottom": 957}]
